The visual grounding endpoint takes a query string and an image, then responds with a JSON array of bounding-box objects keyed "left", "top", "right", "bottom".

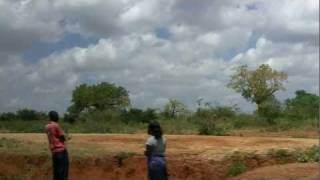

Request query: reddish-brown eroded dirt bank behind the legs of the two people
[{"left": 0, "top": 155, "right": 226, "bottom": 180}]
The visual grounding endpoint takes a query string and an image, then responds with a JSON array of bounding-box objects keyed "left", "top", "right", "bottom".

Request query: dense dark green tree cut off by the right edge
[{"left": 285, "top": 90, "right": 320, "bottom": 119}]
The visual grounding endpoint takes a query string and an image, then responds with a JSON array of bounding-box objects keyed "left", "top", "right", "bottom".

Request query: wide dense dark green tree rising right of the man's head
[{"left": 68, "top": 82, "right": 130, "bottom": 115}]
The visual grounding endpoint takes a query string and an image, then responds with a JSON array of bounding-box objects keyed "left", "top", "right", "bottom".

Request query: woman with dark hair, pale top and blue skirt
[{"left": 145, "top": 122, "right": 168, "bottom": 180}]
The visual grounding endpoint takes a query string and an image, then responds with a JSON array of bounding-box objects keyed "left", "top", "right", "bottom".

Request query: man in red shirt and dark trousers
[{"left": 45, "top": 111, "right": 69, "bottom": 180}]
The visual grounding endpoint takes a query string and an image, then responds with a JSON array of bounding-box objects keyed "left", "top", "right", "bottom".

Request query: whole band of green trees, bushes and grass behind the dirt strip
[{"left": 0, "top": 65, "right": 320, "bottom": 135}]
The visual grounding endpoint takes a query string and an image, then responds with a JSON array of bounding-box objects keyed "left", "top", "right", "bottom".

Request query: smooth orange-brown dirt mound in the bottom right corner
[{"left": 230, "top": 163, "right": 320, "bottom": 180}]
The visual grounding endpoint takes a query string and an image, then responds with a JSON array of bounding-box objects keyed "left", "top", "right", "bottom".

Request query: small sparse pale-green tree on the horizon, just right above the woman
[{"left": 164, "top": 99, "right": 188, "bottom": 118}]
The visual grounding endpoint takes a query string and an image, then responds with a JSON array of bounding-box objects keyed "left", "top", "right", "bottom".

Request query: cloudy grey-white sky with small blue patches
[{"left": 0, "top": 0, "right": 319, "bottom": 112}]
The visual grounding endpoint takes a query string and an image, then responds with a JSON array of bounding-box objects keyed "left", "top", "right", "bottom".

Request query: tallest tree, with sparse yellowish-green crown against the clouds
[{"left": 227, "top": 64, "right": 288, "bottom": 114}]
